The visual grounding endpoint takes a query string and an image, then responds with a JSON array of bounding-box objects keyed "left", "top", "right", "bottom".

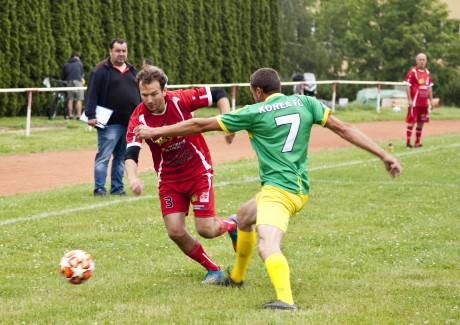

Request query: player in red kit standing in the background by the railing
[{"left": 404, "top": 53, "right": 433, "bottom": 148}]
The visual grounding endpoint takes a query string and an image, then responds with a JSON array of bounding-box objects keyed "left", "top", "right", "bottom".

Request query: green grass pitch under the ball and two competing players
[{"left": 0, "top": 129, "right": 460, "bottom": 324}]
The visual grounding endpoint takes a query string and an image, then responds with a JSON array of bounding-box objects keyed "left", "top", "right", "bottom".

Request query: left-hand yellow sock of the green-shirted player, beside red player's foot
[{"left": 230, "top": 229, "right": 256, "bottom": 282}]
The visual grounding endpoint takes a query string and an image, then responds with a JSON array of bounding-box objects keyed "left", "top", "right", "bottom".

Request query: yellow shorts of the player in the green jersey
[{"left": 256, "top": 185, "right": 308, "bottom": 233}]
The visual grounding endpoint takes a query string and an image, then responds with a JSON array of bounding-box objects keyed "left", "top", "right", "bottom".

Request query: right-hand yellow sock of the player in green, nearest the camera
[{"left": 264, "top": 253, "right": 294, "bottom": 305}]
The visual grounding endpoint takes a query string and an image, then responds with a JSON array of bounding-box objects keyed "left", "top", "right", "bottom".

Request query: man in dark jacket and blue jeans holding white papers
[{"left": 85, "top": 38, "right": 141, "bottom": 196}]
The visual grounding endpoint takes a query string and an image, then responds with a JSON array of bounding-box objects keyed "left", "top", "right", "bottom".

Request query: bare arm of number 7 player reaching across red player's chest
[{"left": 134, "top": 117, "right": 222, "bottom": 139}]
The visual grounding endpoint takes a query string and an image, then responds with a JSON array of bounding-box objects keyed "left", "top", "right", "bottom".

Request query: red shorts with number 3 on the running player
[{"left": 158, "top": 173, "right": 216, "bottom": 218}]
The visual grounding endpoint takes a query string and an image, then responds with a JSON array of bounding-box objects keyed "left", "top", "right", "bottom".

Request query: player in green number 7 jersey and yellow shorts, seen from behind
[{"left": 134, "top": 68, "right": 402, "bottom": 310}]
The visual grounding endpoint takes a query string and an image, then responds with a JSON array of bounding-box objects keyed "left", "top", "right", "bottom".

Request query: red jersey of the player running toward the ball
[{"left": 126, "top": 87, "right": 213, "bottom": 183}]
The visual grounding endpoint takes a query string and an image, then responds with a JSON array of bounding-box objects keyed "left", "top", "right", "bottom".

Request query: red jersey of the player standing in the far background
[{"left": 404, "top": 67, "right": 433, "bottom": 107}]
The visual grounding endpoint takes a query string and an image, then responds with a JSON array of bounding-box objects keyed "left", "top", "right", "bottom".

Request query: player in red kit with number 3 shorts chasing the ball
[{"left": 125, "top": 66, "right": 237, "bottom": 283}]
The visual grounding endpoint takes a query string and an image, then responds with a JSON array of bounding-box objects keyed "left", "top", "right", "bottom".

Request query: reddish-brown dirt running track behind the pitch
[{"left": 0, "top": 121, "right": 460, "bottom": 196}]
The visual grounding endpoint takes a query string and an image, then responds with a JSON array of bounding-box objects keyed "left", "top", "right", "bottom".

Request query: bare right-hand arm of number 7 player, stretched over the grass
[{"left": 325, "top": 115, "right": 402, "bottom": 177}]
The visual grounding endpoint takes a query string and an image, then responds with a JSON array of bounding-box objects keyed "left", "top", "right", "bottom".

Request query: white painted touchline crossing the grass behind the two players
[{"left": 0, "top": 143, "right": 460, "bottom": 226}]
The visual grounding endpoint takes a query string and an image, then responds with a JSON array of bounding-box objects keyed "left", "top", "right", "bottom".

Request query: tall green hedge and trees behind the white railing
[{"left": 0, "top": 0, "right": 460, "bottom": 117}]
